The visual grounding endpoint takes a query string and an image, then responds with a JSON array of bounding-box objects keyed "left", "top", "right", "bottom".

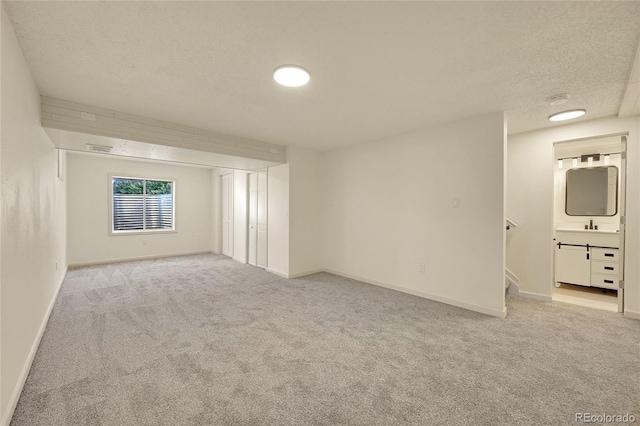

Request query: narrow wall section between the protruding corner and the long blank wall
[{"left": 287, "top": 147, "right": 325, "bottom": 277}]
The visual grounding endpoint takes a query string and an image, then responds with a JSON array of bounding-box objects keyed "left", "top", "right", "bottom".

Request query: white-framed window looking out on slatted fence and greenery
[{"left": 111, "top": 176, "right": 175, "bottom": 233}]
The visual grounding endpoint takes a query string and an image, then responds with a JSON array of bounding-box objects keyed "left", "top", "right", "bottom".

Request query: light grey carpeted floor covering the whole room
[{"left": 11, "top": 255, "right": 640, "bottom": 426}]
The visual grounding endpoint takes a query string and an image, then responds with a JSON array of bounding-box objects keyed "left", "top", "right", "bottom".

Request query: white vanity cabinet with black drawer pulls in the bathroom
[{"left": 555, "top": 230, "right": 622, "bottom": 290}]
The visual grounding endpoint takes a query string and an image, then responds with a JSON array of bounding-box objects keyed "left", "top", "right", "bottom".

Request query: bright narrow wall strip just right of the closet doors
[{"left": 267, "top": 163, "right": 289, "bottom": 277}]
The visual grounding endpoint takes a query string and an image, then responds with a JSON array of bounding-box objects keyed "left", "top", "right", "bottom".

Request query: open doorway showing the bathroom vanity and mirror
[{"left": 552, "top": 135, "right": 626, "bottom": 312}]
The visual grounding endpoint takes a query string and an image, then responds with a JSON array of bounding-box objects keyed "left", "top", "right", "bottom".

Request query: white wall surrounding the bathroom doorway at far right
[{"left": 507, "top": 117, "right": 640, "bottom": 318}]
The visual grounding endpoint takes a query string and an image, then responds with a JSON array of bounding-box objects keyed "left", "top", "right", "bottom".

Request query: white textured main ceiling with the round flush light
[{"left": 3, "top": 1, "right": 640, "bottom": 151}]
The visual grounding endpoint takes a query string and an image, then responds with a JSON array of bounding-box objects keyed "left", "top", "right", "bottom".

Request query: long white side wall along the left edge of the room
[{"left": 0, "top": 10, "right": 67, "bottom": 425}]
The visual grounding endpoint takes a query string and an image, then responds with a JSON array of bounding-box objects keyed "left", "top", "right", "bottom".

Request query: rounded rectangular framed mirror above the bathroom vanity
[{"left": 565, "top": 166, "right": 618, "bottom": 216}]
